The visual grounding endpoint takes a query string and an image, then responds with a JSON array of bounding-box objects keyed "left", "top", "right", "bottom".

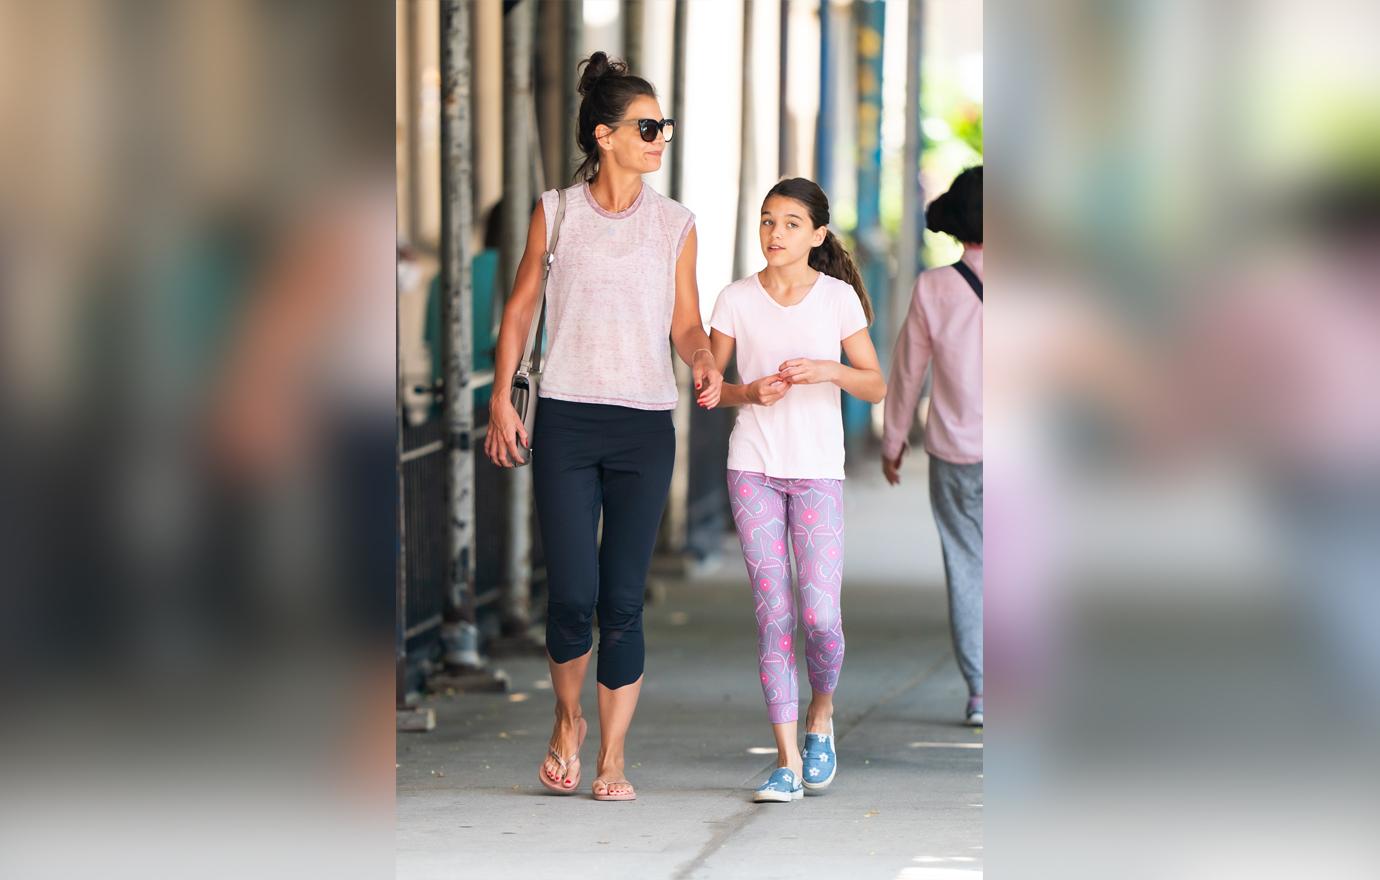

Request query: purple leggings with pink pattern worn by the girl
[{"left": 729, "top": 470, "right": 843, "bottom": 724}]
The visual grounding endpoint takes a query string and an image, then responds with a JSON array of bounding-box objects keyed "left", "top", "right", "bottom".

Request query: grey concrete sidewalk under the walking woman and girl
[{"left": 397, "top": 462, "right": 983, "bottom": 880}]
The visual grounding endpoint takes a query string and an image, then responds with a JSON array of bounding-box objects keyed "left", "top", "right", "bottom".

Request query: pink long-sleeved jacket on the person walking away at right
[{"left": 882, "top": 247, "right": 984, "bottom": 465}]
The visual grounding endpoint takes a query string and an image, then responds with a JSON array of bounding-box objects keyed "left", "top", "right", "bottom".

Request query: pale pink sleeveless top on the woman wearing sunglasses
[{"left": 538, "top": 183, "right": 694, "bottom": 410}]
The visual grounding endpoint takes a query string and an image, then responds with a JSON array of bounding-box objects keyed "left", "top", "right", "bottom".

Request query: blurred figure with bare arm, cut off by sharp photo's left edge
[{"left": 206, "top": 4, "right": 399, "bottom": 800}]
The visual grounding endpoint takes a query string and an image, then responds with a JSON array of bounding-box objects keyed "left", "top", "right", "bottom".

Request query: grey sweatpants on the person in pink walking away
[{"left": 930, "top": 455, "right": 983, "bottom": 695}]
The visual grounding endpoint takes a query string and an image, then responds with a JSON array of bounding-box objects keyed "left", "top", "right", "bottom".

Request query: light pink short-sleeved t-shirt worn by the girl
[{"left": 709, "top": 273, "right": 867, "bottom": 480}]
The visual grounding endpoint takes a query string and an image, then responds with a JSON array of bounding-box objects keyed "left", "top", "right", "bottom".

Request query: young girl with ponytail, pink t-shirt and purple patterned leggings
[{"left": 700, "top": 178, "right": 886, "bottom": 803}]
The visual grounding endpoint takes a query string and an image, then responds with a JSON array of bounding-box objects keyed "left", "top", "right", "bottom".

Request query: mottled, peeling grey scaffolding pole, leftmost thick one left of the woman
[{"left": 440, "top": 0, "right": 483, "bottom": 669}]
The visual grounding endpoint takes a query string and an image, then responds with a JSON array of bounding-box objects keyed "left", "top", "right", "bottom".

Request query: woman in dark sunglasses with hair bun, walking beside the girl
[{"left": 484, "top": 52, "right": 723, "bottom": 800}]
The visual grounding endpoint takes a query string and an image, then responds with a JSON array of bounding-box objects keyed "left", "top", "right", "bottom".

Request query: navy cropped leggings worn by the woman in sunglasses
[{"left": 531, "top": 397, "right": 676, "bottom": 688}]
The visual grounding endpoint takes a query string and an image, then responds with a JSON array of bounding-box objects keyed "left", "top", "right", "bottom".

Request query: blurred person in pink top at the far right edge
[{"left": 1173, "top": 175, "right": 1380, "bottom": 726}]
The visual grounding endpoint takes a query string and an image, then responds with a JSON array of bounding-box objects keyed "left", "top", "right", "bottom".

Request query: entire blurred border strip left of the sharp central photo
[{"left": 0, "top": 0, "right": 395, "bottom": 876}]
